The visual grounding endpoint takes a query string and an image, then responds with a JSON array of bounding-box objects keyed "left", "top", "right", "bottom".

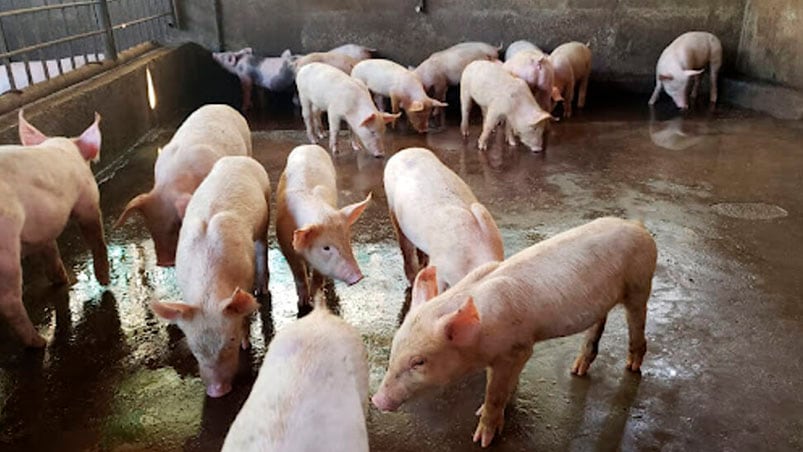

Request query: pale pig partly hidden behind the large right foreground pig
[{"left": 384, "top": 148, "right": 505, "bottom": 290}]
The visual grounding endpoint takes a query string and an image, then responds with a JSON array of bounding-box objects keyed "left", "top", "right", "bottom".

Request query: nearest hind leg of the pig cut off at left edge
[{"left": 0, "top": 218, "right": 47, "bottom": 348}]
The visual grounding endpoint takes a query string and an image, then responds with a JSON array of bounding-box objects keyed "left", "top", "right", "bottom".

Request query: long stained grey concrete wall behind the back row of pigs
[{"left": 210, "top": 0, "right": 744, "bottom": 85}]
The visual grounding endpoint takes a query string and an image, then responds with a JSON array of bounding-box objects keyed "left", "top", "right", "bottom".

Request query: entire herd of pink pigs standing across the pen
[{"left": 0, "top": 32, "right": 722, "bottom": 451}]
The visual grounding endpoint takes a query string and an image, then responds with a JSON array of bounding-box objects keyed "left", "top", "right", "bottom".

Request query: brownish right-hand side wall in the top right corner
[{"left": 738, "top": 0, "right": 803, "bottom": 90}]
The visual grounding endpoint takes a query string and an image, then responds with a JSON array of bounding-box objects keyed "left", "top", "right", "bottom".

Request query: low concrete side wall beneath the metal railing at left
[{"left": 0, "top": 43, "right": 239, "bottom": 173}]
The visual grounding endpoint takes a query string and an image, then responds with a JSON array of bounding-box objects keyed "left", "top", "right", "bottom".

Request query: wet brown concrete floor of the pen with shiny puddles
[{"left": 0, "top": 99, "right": 803, "bottom": 451}]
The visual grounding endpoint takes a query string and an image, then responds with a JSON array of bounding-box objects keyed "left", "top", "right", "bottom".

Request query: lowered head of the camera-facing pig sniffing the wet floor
[{"left": 151, "top": 287, "right": 259, "bottom": 397}]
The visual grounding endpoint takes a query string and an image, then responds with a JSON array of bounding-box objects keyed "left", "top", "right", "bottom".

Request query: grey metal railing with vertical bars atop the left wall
[{"left": 0, "top": 0, "right": 177, "bottom": 95}]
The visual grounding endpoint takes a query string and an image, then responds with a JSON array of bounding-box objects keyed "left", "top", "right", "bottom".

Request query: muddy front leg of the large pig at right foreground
[{"left": 474, "top": 347, "right": 533, "bottom": 447}]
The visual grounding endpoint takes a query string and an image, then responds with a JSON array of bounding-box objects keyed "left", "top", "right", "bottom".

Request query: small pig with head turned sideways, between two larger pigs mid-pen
[{"left": 276, "top": 145, "right": 371, "bottom": 311}]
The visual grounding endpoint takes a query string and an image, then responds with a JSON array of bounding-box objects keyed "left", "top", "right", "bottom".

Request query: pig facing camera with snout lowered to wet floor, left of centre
[{"left": 151, "top": 156, "right": 270, "bottom": 397}]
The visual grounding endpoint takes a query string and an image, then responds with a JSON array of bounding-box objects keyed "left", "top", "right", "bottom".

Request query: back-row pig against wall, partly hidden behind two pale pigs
[{"left": 415, "top": 42, "right": 501, "bottom": 126}]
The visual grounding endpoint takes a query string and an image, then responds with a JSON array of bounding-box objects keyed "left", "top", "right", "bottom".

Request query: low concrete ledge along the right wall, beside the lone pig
[{"left": 720, "top": 78, "right": 803, "bottom": 120}]
